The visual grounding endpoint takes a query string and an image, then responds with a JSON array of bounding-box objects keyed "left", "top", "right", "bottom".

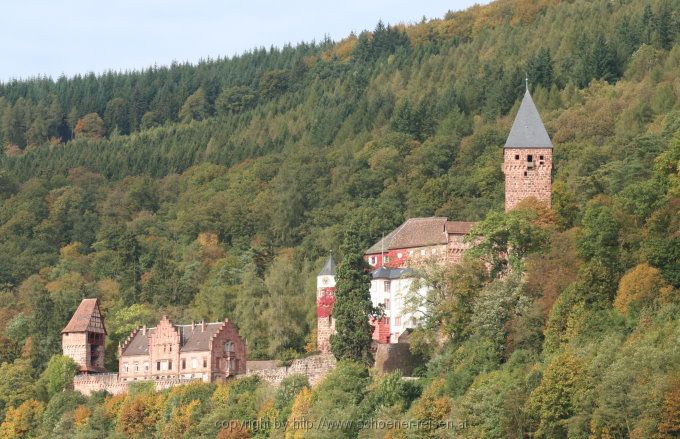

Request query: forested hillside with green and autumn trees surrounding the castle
[{"left": 0, "top": 0, "right": 680, "bottom": 438}]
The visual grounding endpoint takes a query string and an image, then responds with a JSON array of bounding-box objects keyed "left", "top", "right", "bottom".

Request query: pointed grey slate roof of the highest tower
[{"left": 505, "top": 89, "right": 552, "bottom": 148}]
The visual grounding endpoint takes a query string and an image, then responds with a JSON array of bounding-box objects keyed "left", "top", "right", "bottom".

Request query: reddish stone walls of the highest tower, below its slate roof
[{"left": 503, "top": 148, "right": 552, "bottom": 212}]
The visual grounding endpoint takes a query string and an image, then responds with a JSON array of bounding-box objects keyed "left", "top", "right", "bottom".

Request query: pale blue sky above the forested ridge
[{"left": 0, "top": 0, "right": 487, "bottom": 81}]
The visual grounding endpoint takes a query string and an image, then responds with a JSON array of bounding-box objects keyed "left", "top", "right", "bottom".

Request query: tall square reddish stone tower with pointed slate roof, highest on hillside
[{"left": 503, "top": 86, "right": 553, "bottom": 212}]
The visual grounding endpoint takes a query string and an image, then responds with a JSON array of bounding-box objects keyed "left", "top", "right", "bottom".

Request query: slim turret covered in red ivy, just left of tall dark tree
[{"left": 316, "top": 254, "right": 335, "bottom": 354}]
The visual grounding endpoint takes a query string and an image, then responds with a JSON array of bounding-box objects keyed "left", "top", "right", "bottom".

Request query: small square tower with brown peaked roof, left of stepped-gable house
[{"left": 61, "top": 299, "right": 106, "bottom": 373}]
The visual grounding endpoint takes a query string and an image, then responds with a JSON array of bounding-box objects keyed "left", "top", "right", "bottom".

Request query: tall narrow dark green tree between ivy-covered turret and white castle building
[{"left": 330, "top": 232, "right": 376, "bottom": 366}]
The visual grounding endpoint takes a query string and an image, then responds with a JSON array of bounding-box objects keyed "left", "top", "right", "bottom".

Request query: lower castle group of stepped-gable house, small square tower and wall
[{"left": 62, "top": 299, "right": 246, "bottom": 394}]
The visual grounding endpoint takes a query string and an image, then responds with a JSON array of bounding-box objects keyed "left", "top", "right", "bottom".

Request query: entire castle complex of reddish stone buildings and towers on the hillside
[{"left": 62, "top": 88, "right": 552, "bottom": 394}]
